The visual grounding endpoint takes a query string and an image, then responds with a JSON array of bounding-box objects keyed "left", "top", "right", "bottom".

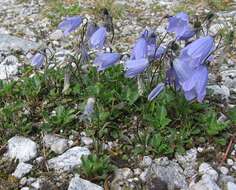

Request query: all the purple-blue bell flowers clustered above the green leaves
[{"left": 32, "top": 12, "right": 218, "bottom": 102}]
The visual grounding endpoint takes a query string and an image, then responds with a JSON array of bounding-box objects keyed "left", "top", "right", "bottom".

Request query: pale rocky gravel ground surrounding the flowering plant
[{"left": 0, "top": 0, "right": 236, "bottom": 190}]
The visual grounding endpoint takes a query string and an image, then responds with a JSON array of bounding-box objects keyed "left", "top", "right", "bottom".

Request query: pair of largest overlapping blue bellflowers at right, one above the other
[{"left": 173, "top": 36, "right": 214, "bottom": 102}]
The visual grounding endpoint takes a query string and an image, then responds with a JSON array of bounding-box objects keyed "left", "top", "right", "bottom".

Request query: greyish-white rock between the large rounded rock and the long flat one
[{"left": 43, "top": 134, "right": 69, "bottom": 154}]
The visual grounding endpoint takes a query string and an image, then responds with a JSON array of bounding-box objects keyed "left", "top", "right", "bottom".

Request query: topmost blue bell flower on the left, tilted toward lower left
[{"left": 58, "top": 16, "right": 83, "bottom": 36}]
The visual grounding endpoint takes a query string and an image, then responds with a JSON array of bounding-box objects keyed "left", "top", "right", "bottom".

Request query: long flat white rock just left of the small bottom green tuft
[{"left": 48, "top": 146, "right": 90, "bottom": 172}]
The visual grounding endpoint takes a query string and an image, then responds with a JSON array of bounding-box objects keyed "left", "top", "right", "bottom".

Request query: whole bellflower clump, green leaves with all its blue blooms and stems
[{"left": 0, "top": 1, "right": 236, "bottom": 172}]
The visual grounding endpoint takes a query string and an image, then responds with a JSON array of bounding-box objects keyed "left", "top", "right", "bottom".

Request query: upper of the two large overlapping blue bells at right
[{"left": 179, "top": 36, "right": 215, "bottom": 67}]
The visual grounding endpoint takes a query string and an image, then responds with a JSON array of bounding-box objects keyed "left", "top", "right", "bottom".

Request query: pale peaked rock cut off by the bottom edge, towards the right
[{"left": 189, "top": 176, "right": 220, "bottom": 190}]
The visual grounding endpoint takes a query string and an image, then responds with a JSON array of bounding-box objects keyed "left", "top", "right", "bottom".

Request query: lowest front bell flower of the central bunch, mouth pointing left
[{"left": 125, "top": 58, "right": 149, "bottom": 78}]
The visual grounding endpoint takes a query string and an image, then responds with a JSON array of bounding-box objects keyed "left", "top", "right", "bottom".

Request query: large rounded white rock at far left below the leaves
[{"left": 6, "top": 136, "right": 38, "bottom": 162}]
